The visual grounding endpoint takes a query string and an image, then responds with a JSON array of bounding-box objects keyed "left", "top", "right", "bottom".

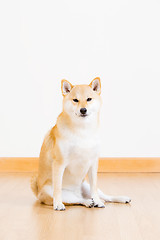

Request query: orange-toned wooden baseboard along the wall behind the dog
[{"left": 0, "top": 158, "right": 160, "bottom": 173}]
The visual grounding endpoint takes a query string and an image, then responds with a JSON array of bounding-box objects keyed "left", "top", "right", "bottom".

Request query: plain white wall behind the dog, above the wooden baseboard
[{"left": 0, "top": 0, "right": 160, "bottom": 157}]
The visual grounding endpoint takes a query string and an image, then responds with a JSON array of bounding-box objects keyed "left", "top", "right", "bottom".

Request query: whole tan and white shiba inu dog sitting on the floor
[{"left": 31, "top": 77, "right": 131, "bottom": 210}]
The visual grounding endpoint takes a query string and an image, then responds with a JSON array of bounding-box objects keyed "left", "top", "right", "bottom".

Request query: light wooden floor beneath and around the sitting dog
[{"left": 0, "top": 173, "right": 160, "bottom": 240}]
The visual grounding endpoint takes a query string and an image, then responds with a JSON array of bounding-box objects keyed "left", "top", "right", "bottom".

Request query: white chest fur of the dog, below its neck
[{"left": 60, "top": 129, "right": 99, "bottom": 188}]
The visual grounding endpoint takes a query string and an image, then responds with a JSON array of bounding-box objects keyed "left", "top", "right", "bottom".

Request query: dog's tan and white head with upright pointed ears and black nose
[{"left": 61, "top": 77, "right": 101, "bottom": 121}]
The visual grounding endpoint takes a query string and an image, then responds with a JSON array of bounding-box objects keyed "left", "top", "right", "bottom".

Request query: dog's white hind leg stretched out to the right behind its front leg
[{"left": 82, "top": 181, "right": 131, "bottom": 203}]
